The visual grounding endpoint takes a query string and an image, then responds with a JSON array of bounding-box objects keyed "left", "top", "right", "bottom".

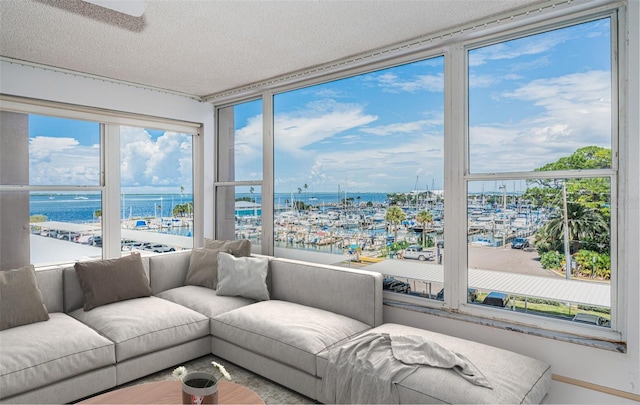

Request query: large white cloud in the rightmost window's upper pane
[{"left": 470, "top": 71, "right": 611, "bottom": 172}]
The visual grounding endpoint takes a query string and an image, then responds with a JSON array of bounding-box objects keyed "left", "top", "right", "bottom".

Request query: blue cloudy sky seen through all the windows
[{"left": 29, "top": 19, "right": 612, "bottom": 193}]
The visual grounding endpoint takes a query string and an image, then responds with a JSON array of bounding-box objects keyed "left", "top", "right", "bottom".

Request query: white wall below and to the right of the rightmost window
[{"left": 384, "top": 0, "right": 640, "bottom": 404}]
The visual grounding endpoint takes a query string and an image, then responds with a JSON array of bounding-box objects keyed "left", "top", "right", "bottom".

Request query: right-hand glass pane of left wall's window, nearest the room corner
[{"left": 120, "top": 127, "right": 193, "bottom": 253}]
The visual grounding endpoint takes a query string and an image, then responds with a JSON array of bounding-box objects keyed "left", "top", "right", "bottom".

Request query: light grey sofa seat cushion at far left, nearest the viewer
[{"left": 0, "top": 310, "right": 116, "bottom": 398}]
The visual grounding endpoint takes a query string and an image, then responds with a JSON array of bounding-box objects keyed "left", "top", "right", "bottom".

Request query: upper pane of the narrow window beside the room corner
[{"left": 218, "top": 100, "right": 262, "bottom": 181}]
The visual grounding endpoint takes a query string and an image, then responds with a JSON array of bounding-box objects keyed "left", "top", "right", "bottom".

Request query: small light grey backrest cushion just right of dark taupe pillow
[{"left": 149, "top": 250, "right": 191, "bottom": 295}]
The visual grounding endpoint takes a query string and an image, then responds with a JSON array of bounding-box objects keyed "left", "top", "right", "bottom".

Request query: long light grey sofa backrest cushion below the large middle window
[{"left": 269, "top": 258, "right": 382, "bottom": 326}]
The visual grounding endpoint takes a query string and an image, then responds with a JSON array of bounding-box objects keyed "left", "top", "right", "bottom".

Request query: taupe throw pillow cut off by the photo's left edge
[{"left": 0, "top": 265, "right": 49, "bottom": 330}]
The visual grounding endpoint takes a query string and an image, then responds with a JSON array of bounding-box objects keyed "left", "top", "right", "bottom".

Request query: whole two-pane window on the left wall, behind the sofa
[{"left": 0, "top": 100, "right": 200, "bottom": 269}]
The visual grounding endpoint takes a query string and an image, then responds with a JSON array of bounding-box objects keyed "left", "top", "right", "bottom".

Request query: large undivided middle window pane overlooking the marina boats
[{"left": 274, "top": 57, "right": 444, "bottom": 297}]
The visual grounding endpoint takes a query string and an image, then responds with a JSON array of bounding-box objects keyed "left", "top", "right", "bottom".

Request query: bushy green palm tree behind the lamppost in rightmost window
[{"left": 545, "top": 202, "right": 609, "bottom": 254}]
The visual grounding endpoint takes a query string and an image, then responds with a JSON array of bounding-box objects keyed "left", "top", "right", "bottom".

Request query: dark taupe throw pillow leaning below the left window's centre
[{"left": 74, "top": 253, "right": 151, "bottom": 311}]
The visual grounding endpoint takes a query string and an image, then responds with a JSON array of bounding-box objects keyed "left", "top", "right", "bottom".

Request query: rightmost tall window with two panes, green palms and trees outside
[{"left": 466, "top": 18, "right": 617, "bottom": 327}]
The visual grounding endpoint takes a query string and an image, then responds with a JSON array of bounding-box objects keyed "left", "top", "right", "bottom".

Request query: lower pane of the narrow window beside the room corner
[{"left": 216, "top": 186, "right": 262, "bottom": 246}]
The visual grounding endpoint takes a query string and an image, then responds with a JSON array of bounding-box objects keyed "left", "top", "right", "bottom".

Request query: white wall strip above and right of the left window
[{"left": 0, "top": 61, "right": 214, "bottom": 237}]
